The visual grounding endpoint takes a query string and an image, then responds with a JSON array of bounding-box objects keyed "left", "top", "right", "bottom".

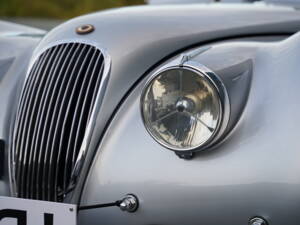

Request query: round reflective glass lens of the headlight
[{"left": 141, "top": 67, "right": 222, "bottom": 151}]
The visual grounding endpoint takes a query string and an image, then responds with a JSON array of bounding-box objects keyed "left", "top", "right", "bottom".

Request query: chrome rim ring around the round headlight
[{"left": 140, "top": 61, "right": 230, "bottom": 154}]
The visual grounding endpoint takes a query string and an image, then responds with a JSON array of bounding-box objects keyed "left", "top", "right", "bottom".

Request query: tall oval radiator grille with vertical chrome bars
[{"left": 12, "top": 43, "right": 105, "bottom": 201}]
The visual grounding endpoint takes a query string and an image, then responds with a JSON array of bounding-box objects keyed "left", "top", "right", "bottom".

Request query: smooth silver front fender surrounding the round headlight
[{"left": 79, "top": 34, "right": 300, "bottom": 225}]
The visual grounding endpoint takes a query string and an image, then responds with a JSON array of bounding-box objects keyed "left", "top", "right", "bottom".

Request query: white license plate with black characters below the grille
[{"left": 0, "top": 197, "right": 77, "bottom": 225}]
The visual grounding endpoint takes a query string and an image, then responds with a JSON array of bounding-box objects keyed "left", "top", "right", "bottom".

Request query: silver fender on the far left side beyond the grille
[{"left": 0, "top": 27, "right": 42, "bottom": 196}]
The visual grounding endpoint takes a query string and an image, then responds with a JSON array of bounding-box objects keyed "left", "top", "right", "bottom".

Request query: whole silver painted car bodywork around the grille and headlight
[{"left": 0, "top": 2, "right": 300, "bottom": 225}]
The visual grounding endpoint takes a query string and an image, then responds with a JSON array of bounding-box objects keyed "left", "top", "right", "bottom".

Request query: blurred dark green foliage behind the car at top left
[{"left": 0, "top": 0, "right": 144, "bottom": 19}]
